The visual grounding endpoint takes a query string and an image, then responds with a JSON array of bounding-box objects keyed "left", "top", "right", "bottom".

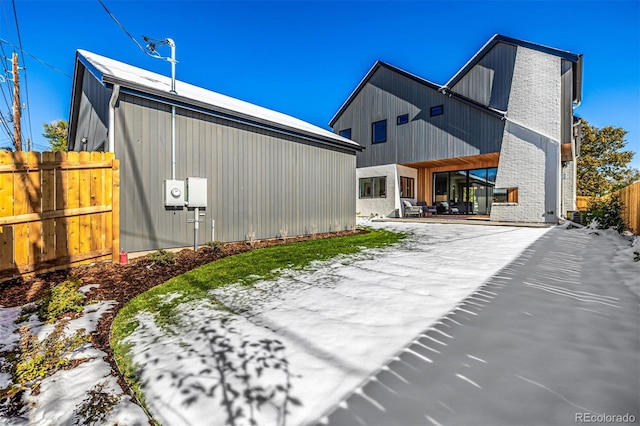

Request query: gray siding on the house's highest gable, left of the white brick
[{"left": 452, "top": 43, "right": 517, "bottom": 111}]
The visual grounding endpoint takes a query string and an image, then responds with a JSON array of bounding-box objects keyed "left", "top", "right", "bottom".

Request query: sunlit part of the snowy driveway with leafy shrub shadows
[{"left": 126, "top": 223, "right": 549, "bottom": 425}]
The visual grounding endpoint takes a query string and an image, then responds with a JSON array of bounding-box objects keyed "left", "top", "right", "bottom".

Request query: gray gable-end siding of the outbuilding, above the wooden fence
[{"left": 73, "top": 72, "right": 111, "bottom": 151}]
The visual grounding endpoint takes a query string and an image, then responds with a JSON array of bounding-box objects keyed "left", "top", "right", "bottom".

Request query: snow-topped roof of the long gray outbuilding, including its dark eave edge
[{"left": 74, "top": 50, "right": 363, "bottom": 150}]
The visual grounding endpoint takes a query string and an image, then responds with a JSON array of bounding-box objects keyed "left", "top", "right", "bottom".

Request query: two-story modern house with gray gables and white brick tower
[{"left": 330, "top": 35, "right": 582, "bottom": 223}]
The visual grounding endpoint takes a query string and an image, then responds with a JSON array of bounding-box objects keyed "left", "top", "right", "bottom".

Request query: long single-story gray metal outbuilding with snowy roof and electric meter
[{"left": 68, "top": 50, "right": 362, "bottom": 251}]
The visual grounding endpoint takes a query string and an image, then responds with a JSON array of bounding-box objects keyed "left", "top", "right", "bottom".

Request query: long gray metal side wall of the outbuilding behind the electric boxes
[{"left": 115, "top": 94, "right": 356, "bottom": 251}]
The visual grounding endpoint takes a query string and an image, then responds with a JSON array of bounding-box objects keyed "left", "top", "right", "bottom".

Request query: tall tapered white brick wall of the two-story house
[{"left": 491, "top": 47, "right": 561, "bottom": 222}]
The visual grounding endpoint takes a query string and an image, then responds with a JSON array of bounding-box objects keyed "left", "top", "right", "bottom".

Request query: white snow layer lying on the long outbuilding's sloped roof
[{"left": 77, "top": 50, "right": 361, "bottom": 149}]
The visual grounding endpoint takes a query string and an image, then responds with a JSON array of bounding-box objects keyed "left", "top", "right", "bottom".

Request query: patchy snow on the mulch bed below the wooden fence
[{"left": 0, "top": 302, "right": 148, "bottom": 426}]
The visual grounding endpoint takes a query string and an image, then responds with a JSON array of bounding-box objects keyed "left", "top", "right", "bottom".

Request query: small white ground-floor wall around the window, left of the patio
[{"left": 356, "top": 164, "right": 399, "bottom": 217}]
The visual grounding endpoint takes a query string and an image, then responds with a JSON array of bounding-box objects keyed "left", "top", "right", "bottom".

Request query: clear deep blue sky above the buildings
[{"left": 0, "top": 0, "right": 640, "bottom": 168}]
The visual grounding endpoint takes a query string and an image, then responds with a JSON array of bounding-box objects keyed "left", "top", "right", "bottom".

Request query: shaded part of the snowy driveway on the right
[{"left": 326, "top": 227, "right": 640, "bottom": 426}]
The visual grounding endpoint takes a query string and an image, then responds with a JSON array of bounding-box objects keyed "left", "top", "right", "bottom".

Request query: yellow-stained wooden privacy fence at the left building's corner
[{"left": 0, "top": 152, "right": 120, "bottom": 281}]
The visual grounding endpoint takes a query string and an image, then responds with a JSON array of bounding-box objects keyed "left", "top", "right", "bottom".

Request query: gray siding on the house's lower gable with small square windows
[{"left": 334, "top": 68, "right": 504, "bottom": 167}]
